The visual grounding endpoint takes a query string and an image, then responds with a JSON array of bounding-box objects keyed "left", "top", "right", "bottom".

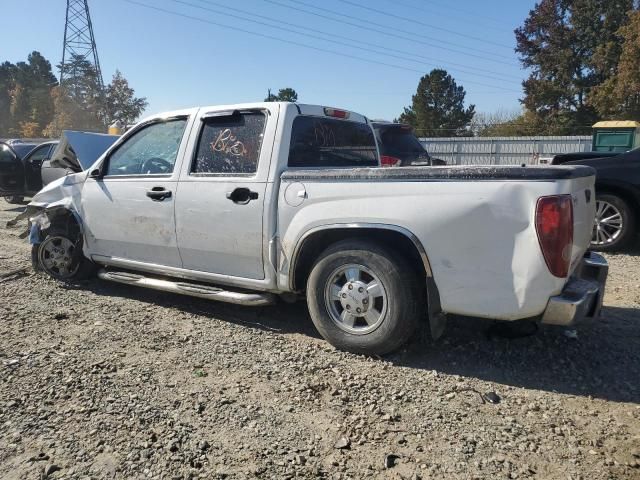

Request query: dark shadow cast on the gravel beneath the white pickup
[{"left": 76, "top": 280, "right": 640, "bottom": 403}]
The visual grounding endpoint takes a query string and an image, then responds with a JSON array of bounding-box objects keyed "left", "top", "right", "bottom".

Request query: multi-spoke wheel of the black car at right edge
[{"left": 591, "top": 193, "right": 636, "bottom": 252}]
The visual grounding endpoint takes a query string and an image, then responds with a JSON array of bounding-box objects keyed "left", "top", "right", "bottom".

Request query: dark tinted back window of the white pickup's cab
[{"left": 289, "top": 116, "right": 378, "bottom": 168}]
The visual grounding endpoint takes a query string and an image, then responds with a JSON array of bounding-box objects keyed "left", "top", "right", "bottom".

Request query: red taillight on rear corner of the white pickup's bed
[{"left": 536, "top": 195, "right": 573, "bottom": 278}]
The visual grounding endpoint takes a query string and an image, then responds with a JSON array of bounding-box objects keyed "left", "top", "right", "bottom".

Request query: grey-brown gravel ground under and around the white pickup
[{"left": 0, "top": 200, "right": 640, "bottom": 480}]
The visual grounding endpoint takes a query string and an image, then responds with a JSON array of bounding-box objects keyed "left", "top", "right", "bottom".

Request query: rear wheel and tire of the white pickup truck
[{"left": 307, "top": 240, "right": 424, "bottom": 355}]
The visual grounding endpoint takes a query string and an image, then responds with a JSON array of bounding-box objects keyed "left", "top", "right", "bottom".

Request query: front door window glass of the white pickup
[{"left": 105, "top": 118, "right": 187, "bottom": 176}]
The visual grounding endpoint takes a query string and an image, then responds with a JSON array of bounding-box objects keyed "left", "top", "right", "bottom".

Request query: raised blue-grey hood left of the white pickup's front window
[{"left": 51, "top": 130, "right": 120, "bottom": 172}]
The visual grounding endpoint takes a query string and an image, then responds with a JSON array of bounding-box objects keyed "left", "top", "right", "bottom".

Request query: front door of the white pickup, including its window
[{"left": 81, "top": 115, "right": 190, "bottom": 268}]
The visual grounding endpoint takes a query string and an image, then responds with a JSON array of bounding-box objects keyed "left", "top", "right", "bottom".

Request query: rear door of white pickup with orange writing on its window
[{"left": 176, "top": 105, "right": 278, "bottom": 280}]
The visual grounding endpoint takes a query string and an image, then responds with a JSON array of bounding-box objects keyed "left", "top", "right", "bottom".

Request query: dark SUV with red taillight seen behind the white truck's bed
[{"left": 371, "top": 122, "right": 446, "bottom": 167}]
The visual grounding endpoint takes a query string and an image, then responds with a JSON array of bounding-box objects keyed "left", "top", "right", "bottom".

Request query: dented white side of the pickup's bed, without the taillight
[{"left": 278, "top": 166, "right": 595, "bottom": 320}]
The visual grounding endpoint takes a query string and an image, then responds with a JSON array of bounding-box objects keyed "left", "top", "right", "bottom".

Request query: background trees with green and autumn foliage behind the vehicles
[{"left": 0, "top": 0, "right": 640, "bottom": 137}]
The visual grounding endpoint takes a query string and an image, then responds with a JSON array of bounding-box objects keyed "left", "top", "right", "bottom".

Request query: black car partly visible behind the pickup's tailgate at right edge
[{"left": 564, "top": 148, "right": 640, "bottom": 252}]
